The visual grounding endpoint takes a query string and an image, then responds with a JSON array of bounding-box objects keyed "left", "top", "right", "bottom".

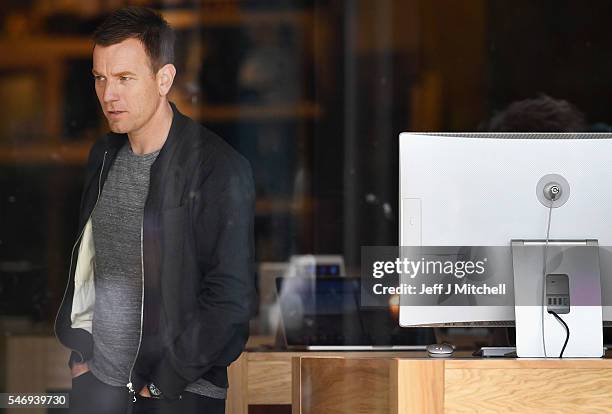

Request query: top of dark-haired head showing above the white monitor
[{"left": 486, "top": 95, "right": 588, "bottom": 132}]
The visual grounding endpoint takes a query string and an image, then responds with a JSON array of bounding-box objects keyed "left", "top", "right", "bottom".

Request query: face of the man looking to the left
[{"left": 92, "top": 39, "right": 161, "bottom": 133}]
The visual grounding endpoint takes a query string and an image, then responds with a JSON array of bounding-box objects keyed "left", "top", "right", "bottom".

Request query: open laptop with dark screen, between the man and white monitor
[{"left": 276, "top": 277, "right": 435, "bottom": 351}]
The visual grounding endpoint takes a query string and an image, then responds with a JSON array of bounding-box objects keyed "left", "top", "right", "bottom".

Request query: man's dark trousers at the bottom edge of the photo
[{"left": 70, "top": 371, "right": 225, "bottom": 414}]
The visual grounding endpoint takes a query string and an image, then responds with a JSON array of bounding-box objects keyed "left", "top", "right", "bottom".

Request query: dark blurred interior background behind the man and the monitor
[{"left": 0, "top": 0, "right": 612, "bottom": 360}]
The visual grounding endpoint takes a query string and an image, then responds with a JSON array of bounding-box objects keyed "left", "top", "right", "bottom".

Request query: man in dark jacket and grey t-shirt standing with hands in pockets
[{"left": 55, "top": 8, "right": 255, "bottom": 414}]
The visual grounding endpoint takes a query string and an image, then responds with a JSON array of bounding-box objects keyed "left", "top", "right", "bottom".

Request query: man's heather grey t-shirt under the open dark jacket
[{"left": 89, "top": 142, "right": 226, "bottom": 398}]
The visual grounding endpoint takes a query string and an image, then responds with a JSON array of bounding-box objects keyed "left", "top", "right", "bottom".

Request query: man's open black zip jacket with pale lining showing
[{"left": 55, "top": 104, "right": 256, "bottom": 399}]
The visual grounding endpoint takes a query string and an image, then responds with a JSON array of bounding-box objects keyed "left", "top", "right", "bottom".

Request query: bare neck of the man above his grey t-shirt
[{"left": 128, "top": 100, "right": 173, "bottom": 155}]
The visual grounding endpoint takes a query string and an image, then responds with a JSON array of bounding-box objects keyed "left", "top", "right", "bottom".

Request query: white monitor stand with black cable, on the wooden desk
[{"left": 512, "top": 239, "right": 603, "bottom": 358}]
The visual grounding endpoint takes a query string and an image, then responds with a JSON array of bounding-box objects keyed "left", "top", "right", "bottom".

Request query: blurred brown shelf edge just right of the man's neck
[{"left": 177, "top": 102, "right": 321, "bottom": 122}]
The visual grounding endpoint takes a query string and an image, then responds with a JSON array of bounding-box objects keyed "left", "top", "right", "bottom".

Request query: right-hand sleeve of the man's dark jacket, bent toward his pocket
[{"left": 150, "top": 154, "right": 256, "bottom": 399}]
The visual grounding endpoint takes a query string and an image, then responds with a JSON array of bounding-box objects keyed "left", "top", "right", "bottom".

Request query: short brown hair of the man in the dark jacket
[{"left": 93, "top": 6, "right": 175, "bottom": 73}]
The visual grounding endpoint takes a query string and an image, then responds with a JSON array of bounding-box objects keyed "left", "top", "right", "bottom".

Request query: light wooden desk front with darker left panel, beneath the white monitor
[{"left": 292, "top": 356, "right": 612, "bottom": 414}]
